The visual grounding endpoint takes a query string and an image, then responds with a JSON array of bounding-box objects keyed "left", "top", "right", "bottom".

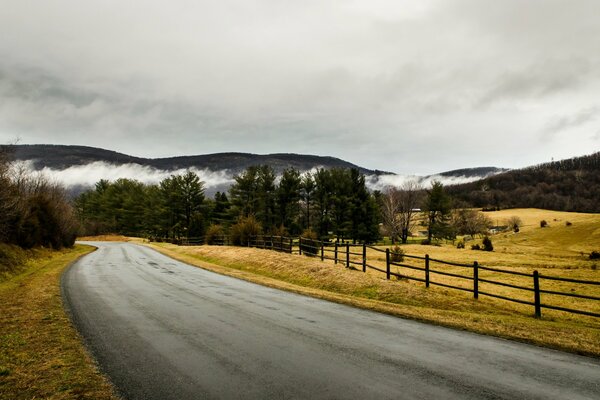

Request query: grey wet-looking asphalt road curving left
[{"left": 62, "top": 242, "right": 600, "bottom": 400}]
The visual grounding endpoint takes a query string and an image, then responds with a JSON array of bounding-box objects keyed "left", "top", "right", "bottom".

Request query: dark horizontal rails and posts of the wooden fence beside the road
[{"left": 162, "top": 235, "right": 600, "bottom": 318}]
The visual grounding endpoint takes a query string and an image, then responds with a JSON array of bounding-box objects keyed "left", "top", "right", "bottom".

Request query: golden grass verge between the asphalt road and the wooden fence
[{"left": 151, "top": 243, "right": 600, "bottom": 357}]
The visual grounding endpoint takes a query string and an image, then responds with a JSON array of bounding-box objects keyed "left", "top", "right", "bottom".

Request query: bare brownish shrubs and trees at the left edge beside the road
[{"left": 0, "top": 146, "right": 78, "bottom": 249}]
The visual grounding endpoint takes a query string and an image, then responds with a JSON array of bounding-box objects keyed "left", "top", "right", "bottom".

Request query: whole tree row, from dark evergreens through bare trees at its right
[{"left": 75, "top": 165, "right": 491, "bottom": 247}]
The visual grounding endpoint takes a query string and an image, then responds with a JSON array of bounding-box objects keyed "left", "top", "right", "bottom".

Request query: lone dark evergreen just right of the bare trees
[{"left": 423, "top": 181, "right": 454, "bottom": 243}]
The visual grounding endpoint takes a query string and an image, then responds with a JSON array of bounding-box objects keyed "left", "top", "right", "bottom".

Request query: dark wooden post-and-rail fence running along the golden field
[{"left": 163, "top": 235, "right": 600, "bottom": 318}]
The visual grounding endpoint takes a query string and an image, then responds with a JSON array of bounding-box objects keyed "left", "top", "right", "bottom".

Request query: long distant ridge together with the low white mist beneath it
[{"left": 8, "top": 145, "right": 504, "bottom": 196}]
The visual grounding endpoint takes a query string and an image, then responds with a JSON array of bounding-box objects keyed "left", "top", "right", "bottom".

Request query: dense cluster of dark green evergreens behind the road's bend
[{"left": 74, "top": 165, "right": 379, "bottom": 242}]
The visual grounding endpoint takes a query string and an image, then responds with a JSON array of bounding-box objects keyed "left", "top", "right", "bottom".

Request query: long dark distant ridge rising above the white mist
[{"left": 8, "top": 144, "right": 391, "bottom": 175}]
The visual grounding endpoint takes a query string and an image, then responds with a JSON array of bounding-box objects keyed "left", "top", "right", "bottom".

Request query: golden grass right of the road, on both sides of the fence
[{"left": 148, "top": 210, "right": 600, "bottom": 356}]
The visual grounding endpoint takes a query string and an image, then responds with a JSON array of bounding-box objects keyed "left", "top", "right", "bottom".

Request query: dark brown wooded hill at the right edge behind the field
[{"left": 447, "top": 152, "right": 600, "bottom": 212}]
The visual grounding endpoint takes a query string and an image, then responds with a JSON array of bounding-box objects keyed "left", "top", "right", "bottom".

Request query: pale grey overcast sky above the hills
[{"left": 0, "top": 0, "right": 600, "bottom": 174}]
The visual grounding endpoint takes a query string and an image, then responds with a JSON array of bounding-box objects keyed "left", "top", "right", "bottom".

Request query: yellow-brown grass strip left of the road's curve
[{"left": 0, "top": 245, "right": 117, "bottom": 399}]
